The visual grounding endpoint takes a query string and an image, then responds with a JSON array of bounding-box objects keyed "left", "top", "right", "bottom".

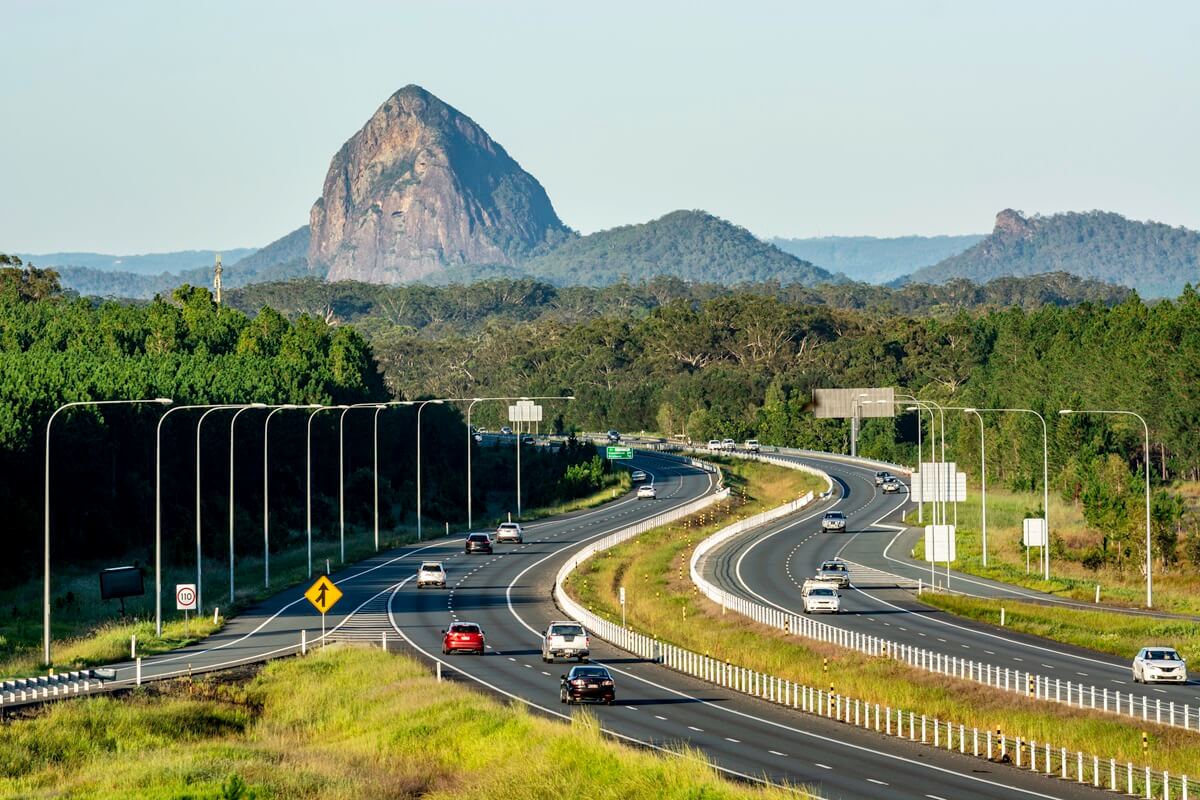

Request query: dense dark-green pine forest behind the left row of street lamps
[{"left": 0, "top": 255, "right": 590, "bottom": 592}]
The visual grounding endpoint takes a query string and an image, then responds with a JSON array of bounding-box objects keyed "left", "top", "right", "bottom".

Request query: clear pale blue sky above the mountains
[{"left": 0, "top": 0, "right": 1200, "bottom": 253}]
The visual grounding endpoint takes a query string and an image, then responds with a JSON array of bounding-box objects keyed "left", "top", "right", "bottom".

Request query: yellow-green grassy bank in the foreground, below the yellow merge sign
[{"left": 0, "top": 646, "right": 811, "bottom": 800}]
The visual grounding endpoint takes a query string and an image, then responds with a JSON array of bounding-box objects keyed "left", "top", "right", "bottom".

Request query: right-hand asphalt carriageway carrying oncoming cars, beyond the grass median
[{"left": 704, "top": 457, "right": 1200, "bottom": 715}]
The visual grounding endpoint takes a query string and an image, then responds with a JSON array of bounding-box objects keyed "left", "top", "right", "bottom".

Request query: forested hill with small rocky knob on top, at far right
[{"left": 908, "top": 209, "right": 1200, "bottom": 297}]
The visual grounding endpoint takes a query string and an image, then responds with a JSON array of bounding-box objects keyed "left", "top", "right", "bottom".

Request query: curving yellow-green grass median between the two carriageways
[{"left": 568, "top": 464, "right": 1200, "bottom": 775}]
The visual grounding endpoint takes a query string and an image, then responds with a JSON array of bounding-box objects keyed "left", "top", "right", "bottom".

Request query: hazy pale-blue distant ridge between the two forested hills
[{"left": 767, "top": 234, "right": 984, "bottom": 283}]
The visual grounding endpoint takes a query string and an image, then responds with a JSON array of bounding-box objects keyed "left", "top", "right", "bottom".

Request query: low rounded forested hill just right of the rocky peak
[{"left": 518, "top": 211, "right": 834, "bottom": 285}]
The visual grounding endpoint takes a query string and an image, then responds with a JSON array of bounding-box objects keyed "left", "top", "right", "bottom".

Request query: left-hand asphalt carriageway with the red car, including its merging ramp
[{"left": 70, "top": 455, "right": 1094, "bottom": 800}]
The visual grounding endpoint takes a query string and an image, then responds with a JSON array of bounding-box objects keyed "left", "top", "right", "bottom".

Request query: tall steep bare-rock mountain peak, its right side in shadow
[{"left": 308, "top": 84, "right": 566, "bottom": 283}]
